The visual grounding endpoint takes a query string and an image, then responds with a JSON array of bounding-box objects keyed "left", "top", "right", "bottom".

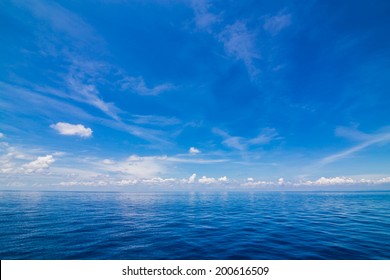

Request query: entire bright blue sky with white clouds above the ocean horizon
[{"left": 0, "top": 0, "right": 390, "bottom": 190}]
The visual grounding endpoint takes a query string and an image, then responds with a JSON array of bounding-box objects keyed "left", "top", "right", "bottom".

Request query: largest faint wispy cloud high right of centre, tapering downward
[{"left": 218, "top": 21, "right": 260, "bottom": 77}]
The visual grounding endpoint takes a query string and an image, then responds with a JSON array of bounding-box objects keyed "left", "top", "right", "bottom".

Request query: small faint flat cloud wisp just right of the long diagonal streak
[{"left": 121, "top": 77, "right": 176, "bottom": 95}]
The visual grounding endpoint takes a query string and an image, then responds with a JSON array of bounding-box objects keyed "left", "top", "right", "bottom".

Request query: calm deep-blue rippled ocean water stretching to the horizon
[{"left": 0, "top": 191, "right": 390, "bottom": 260}]
